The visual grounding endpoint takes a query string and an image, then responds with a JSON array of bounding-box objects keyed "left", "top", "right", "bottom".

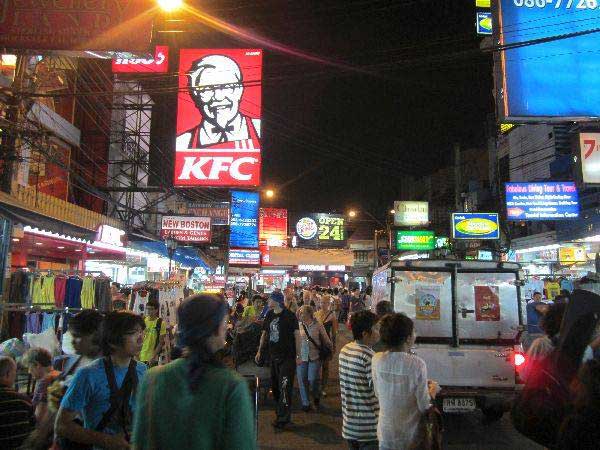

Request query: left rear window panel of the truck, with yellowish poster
[{"left": 394, "top": 270, "right": 452, "bottom": 339}]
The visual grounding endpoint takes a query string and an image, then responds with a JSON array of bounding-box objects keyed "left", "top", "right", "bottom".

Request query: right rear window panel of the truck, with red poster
[{"left": 457, "top": 272, "right": 519, "bottom": 341}]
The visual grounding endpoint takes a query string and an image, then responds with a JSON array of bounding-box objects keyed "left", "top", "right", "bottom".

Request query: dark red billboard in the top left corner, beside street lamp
[{"left": 0, "top": 0, "right": 155, "bottom": 52}]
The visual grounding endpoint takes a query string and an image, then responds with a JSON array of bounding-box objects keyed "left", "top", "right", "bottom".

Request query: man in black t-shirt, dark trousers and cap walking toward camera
[{"left": 256, "top": 292, "right": 300, "bottom": 429}]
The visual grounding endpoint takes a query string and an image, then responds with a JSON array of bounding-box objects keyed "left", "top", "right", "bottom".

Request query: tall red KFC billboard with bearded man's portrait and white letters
[{"left": 174, "top": 49, "right": 262, "bottom": 187}]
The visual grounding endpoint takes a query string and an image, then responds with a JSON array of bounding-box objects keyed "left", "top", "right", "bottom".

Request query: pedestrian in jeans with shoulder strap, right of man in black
[{"left": 296, "top": 305, "right": 333, "bottom": 412}]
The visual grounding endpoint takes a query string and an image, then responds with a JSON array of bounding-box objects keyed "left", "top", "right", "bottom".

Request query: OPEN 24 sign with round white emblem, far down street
[{"left": 293, "top": 213, "right": 346, "bottom": 248}]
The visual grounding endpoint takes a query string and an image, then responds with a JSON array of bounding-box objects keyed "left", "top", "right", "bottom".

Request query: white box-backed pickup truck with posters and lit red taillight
[{"left": 373, "top": 259, "right": 525, "bottom": 420}]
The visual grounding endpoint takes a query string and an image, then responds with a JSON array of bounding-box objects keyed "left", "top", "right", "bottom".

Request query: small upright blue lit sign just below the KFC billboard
[{"left": 229, "top": 191, "right": 259, "bottom": 248}]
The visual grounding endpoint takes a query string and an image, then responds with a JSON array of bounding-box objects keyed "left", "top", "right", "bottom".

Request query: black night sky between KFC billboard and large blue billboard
[{"left": 171, "top": 0, "right": 493, "bottom": 216}]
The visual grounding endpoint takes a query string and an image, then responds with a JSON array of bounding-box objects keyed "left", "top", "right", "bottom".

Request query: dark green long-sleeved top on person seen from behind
[{"left": 133, "top": 359, "right": 257, "bottom": 450}]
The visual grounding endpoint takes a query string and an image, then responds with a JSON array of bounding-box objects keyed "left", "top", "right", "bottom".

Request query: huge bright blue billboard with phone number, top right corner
[{"left": 494, "top": 0, "right": 600, "bottom": 121}]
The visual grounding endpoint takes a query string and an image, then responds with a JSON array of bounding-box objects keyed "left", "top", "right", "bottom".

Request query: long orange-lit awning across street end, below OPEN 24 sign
[{"left": 269, "top": 247, "right": 354, "bottom": 267}]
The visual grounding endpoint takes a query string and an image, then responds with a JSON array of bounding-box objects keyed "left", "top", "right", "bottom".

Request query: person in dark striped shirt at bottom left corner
[{"left": 0, "top": 356, "right": 35, "bottom": 450}]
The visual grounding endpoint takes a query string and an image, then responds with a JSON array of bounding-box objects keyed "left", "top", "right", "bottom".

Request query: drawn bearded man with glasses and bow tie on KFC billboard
[{"left": 176, "top": 55, "right": 260, "bottom": 150}]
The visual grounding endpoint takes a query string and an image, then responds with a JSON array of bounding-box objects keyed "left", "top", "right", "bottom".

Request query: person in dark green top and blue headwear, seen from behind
[{"left": 133, "top": 294, "right": 257, "bottom": 450}]
